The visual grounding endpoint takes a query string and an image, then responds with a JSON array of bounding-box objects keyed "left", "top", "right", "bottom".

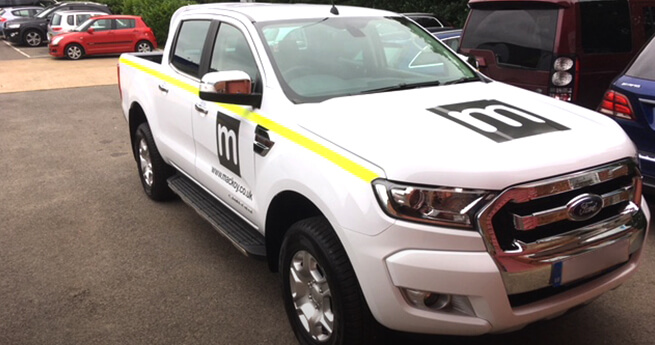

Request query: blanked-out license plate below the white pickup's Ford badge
[{"left": 551, "top": 240, "right": 630, "bottom": 286}]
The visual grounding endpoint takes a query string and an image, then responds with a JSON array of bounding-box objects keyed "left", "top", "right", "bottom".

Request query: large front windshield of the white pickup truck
[{"left": 257, "top": 17, "right": 479, "bottom": 103}]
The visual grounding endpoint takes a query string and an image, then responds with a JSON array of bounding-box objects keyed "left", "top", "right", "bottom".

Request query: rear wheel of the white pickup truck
[{"left": 134, "top": 123, "right": 175, "bottom": 201}]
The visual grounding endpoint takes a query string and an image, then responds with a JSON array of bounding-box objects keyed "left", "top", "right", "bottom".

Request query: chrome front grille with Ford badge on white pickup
[{"left": 478, "top": 159, "right": 647, "bottom": 296}]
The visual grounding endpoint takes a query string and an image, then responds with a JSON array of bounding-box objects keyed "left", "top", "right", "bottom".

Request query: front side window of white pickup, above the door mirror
[{"left": 209, "top": 23, "right": 257, "bottom": 82}]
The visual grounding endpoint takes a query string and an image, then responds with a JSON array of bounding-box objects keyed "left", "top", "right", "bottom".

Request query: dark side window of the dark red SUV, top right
[{"left": 580, "top": 0, "right": 632, "bottom": 54}]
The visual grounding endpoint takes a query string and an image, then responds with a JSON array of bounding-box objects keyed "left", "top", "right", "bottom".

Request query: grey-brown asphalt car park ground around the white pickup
[{"left": 0, "top": 42, "right": 655, "bottom": 345}]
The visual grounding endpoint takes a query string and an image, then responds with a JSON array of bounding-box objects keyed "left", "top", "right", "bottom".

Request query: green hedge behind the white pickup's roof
[{"left": 96, "top": 0, "right": 468, "bottom": 47}]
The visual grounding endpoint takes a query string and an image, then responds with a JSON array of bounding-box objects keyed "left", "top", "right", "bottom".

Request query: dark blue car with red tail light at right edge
[{"left": 598, "top": 36, "right": 655, "bottom": 188}]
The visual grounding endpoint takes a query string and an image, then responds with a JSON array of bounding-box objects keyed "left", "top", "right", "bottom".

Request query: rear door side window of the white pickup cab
[{"left": 171, "top": 20, "right": 211, "bottom": 77}]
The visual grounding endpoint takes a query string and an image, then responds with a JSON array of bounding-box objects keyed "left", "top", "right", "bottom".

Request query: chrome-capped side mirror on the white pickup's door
[{"left": 199, "top": 71, "right": 262, "bottom": 108}]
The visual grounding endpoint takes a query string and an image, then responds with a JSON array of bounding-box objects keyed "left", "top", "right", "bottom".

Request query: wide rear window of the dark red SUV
[{"left": 461, "top": 4, "right": 558, "bottom": 71}]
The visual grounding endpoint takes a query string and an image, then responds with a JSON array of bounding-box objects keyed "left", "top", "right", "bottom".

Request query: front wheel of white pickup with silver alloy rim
[{"left": 279, "top": 217, "right": 379, "bottom": 345}]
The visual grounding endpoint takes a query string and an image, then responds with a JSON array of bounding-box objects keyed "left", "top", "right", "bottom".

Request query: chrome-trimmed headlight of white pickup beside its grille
[{"left": 373, "top": 179, "right": 495, "bottom": 229}]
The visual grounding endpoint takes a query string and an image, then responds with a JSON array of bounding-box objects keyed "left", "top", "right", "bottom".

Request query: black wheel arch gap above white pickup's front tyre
[{"left": 266, "top": 191, "right": 324, "bottom": 272}]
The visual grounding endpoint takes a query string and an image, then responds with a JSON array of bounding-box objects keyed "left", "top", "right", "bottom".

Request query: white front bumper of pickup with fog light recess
[{"left": 348, "top": 202, "right": 650, "bottom": 335}]
